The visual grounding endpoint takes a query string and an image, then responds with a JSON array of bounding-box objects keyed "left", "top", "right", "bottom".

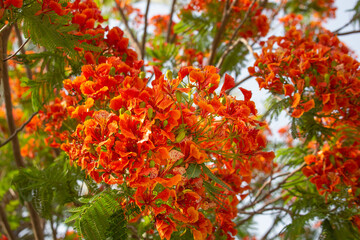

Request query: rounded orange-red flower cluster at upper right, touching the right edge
[{"left": 249, "top": 22, "right": 360, "bottom": 124}]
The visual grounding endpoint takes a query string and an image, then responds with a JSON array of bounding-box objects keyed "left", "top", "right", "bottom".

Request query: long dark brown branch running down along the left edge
[{"left": 0, "top": 24, "right": 44, "bottom": 240}]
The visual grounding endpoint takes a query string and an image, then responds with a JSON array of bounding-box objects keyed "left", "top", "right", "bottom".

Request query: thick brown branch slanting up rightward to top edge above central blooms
[{"left": 206, "top": 0, "right": 237, "bottom": 65}]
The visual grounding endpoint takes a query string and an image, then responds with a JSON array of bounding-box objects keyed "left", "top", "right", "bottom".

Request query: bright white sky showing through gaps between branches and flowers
[{"left": 110, "top": 0, "right": 360, "bottom": 236}]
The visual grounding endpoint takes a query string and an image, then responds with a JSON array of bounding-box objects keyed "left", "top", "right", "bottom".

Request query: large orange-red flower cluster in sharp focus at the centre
[{"left": 58, "top": 57, "right": 274, "bottom": 239}]
